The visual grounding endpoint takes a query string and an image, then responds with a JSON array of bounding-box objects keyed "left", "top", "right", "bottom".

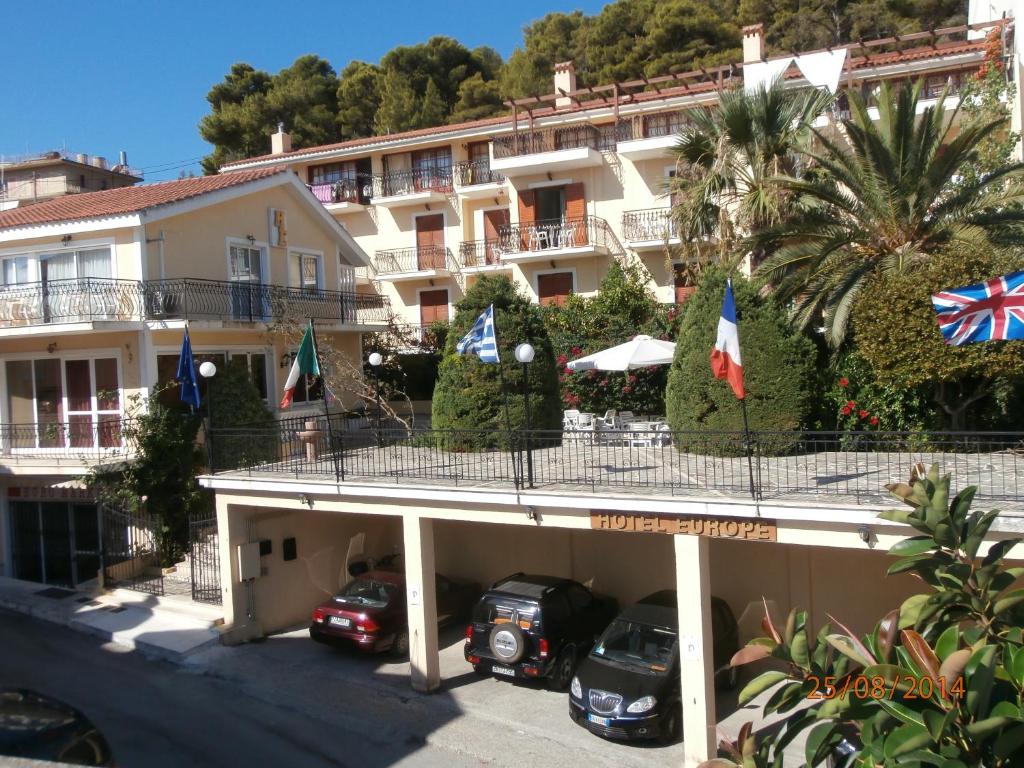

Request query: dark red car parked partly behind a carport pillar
[{"left": 309, "top": 569, "right": 480, "bottom": 656}]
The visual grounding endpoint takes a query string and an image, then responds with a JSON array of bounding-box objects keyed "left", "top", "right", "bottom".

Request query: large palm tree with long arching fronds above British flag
[{"left": 753, "top": 82, "right": 1024, "bottom": 347}]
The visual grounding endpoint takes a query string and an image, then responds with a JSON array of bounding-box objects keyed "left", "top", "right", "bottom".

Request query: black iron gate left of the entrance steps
[{"left": 99, "top": 504, "right": 164, "bottom": 596}]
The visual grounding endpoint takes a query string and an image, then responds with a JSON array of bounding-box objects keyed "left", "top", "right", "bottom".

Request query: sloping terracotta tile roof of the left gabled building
[{"left": 0, "top": 166, "right": 286, "bottom": 229}]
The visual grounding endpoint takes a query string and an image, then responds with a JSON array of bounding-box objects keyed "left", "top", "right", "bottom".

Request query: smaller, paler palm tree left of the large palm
[{"left": 671, "top": 78, "right": 833, "bottom": 259}]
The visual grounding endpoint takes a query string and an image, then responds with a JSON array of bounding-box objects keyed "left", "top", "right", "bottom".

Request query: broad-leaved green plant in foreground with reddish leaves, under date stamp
[{"left": 705, "top": 466, "right": 1024, "bottom": 768}]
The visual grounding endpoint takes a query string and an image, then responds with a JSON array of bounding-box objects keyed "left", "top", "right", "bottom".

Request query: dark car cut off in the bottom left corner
[{"left": 0, "top": 689, "right": 114, "bottom": 766}]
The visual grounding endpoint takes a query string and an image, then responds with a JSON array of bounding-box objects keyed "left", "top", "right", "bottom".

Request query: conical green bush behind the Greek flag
[{"left": 432, "top": 275, "right": 562, "bottom": 450}]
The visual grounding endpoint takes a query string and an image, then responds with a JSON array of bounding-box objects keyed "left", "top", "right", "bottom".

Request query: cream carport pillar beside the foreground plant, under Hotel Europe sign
[{"left": 673, "top": 535, "right": 718, "bottom": 768}]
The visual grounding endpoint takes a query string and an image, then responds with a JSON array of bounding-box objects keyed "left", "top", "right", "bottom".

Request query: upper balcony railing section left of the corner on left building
[{"left": 0, "top": 278, "right": 142, "bottom": 328}]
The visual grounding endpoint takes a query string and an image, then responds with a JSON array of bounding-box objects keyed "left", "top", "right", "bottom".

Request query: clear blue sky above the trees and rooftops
[{"left": 0, "top": 0, "right": 608, "bottom": 181}]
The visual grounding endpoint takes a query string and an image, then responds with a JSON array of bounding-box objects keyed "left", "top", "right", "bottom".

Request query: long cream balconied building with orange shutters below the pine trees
[{"left": 222, "top": 23, "right": 997, "bottom": 339}]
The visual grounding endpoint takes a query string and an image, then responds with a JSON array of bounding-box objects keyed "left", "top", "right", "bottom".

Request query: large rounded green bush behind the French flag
[{"left": 665, "top": 271, "right": 816, "bottom": 454}]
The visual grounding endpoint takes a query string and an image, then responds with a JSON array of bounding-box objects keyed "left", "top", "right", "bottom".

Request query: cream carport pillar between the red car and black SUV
[{"left": 402, "top": 515, "right": 441, "bottom": 693}]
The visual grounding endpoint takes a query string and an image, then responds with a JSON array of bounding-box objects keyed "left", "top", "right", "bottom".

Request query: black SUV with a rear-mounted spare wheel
[{"left": 464, "top": 573, "right": 616, "bottom": 690}]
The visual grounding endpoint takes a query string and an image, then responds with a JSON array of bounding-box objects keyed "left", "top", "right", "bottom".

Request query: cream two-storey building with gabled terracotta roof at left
[{"left": 0, "top": 169, "right": 388, "bottom": 585}]
